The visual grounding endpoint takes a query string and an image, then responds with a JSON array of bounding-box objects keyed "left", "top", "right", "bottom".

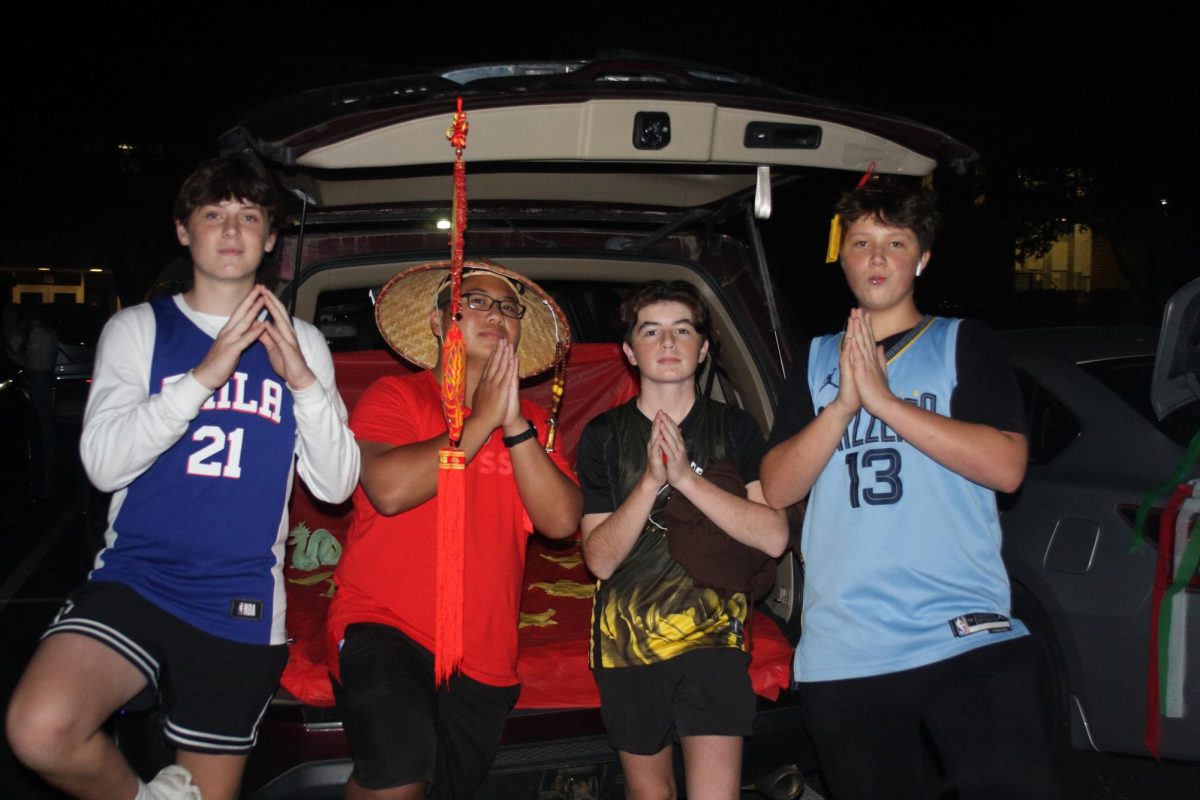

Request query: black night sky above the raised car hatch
[{"left": 0, "top": 2, "right": 1200, "bottom": 302}]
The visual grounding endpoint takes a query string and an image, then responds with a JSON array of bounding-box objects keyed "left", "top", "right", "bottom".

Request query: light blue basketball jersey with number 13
[{"left": 794, "top": 318, "right": 1026, "bottom": 681}]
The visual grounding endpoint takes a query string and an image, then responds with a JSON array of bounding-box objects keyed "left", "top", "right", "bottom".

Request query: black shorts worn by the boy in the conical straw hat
[{"left": 334, "top": 622, "right": 521, "bottom": 800}]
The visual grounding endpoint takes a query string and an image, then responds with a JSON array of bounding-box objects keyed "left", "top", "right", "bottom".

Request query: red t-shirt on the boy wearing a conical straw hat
[{"left": 326, "top": 371, "right": 570, "bottom": 686}]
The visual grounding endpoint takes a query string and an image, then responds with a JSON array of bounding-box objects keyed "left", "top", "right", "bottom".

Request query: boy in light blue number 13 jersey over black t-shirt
[{"left": 762, "top": 185, "right": 1058, "bottom": 800}]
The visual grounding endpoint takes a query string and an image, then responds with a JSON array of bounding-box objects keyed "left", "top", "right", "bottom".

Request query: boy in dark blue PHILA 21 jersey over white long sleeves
[{"left": 7, "top": 157, "right": 359, "bottom": 800}]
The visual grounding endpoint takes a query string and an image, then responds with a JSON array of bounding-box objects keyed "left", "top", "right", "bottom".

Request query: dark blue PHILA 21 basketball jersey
[{"left": 91, "top": 297, "right": 296, "bottom": 644}]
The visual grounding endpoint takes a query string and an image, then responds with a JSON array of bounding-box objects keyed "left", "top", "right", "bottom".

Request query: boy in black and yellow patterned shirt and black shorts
[{"left": 578, "top": 281, "right": 787, "bottom": 798}]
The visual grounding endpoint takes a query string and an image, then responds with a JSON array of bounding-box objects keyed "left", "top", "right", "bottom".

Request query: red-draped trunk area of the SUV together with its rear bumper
[{"left": 236, "top": 343, "right": 799, "bottom": 800}]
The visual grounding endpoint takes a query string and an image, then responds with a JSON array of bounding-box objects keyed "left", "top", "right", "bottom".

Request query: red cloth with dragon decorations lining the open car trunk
[{"left": 283, "top": 344, "right": 791, "bottom": 709}]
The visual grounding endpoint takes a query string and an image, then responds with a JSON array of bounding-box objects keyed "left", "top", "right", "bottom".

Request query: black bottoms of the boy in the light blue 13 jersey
[{"left": 799, "top": 637, "right": 1061, "bottom": 800}]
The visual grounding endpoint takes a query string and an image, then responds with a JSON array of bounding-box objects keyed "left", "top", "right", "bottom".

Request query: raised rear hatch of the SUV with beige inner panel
[{"left": 221, "top": 59, "right": 978, "bottom": 398}]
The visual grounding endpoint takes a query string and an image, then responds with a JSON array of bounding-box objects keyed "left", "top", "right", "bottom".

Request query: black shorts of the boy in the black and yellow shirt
[{"left": 595, "top": 648, "right": 756, "bottom": 756}]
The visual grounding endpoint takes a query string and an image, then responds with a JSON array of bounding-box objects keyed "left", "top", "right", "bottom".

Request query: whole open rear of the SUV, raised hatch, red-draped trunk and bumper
[{"left": 208, "top": 59, "right": 977, "bottom": 800}]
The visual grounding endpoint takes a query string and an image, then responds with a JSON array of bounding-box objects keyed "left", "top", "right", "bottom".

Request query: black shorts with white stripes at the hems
[{"left": 42, "top": 581, "right": 288, "bottom": 756}]
